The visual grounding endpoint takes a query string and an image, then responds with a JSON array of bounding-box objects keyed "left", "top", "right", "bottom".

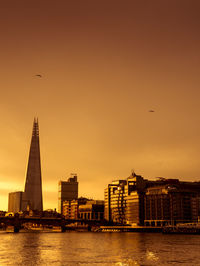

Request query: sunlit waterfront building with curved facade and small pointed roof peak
[{"left": 104, "top": 173, "right": 145, "bottom": 225}]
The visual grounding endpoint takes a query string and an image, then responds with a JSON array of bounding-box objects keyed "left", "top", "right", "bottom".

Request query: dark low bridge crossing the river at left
[{"left": 0, "top": 215, "right": 111, "bottom": 232}]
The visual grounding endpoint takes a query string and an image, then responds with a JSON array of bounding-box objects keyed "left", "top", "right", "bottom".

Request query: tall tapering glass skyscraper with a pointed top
[{"left": 23, "top": 118, "right": 43, "bottom": 211}]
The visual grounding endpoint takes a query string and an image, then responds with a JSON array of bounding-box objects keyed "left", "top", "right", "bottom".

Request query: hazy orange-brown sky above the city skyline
[{"left": 0, "top": 0, "right": 200, "bottom": 210}]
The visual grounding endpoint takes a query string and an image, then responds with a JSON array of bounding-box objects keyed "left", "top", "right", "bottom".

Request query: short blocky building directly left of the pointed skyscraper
[{"left": 8, "top": 191, "right": 23, "bottom": 213}]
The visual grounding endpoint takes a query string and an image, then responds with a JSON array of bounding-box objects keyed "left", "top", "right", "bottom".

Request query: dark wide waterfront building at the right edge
[{"left": 144, "top": 179, "right": 200, "bottom": 226}]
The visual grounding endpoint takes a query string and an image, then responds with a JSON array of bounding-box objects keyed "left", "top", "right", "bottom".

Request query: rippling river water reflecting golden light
[{"left": 0, "top": 232, "right": 200, "bottom": 266}]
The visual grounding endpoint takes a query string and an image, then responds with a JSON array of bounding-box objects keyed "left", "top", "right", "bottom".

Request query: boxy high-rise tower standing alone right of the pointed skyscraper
[{"left": 58, "top": 174, "right": 78, "bottom": 214}]
